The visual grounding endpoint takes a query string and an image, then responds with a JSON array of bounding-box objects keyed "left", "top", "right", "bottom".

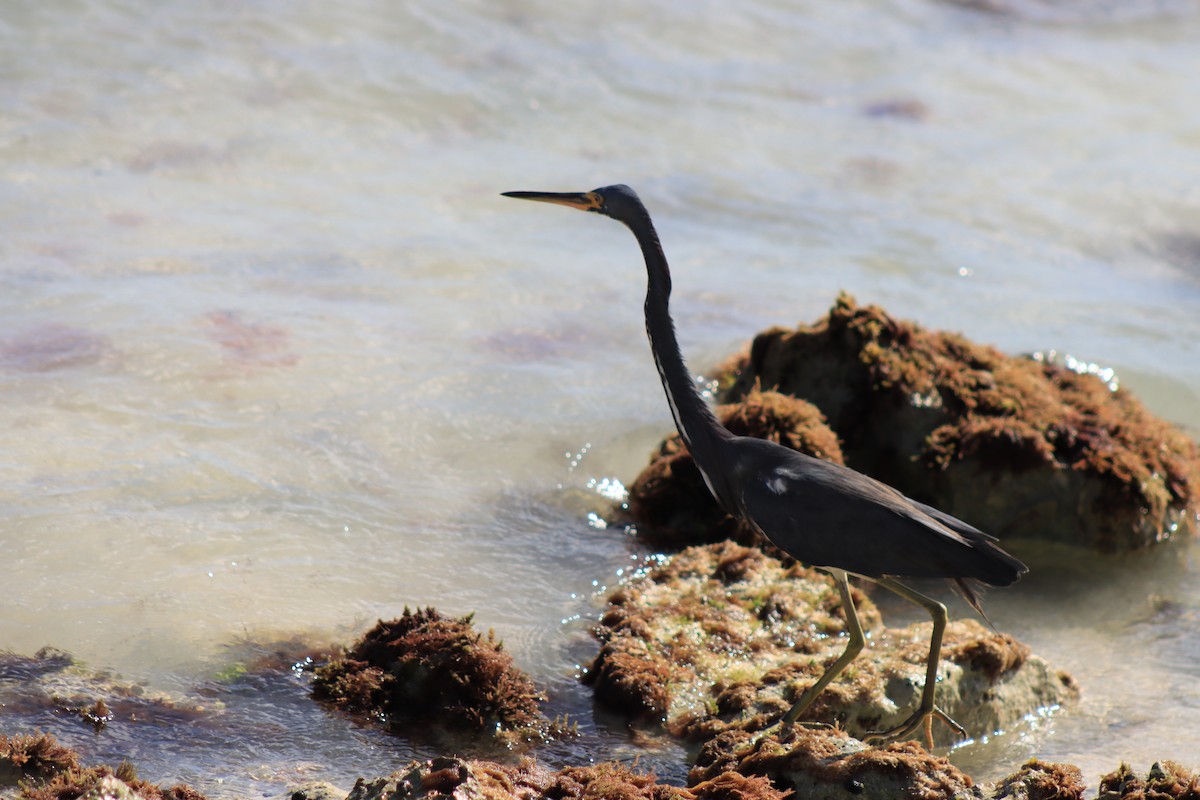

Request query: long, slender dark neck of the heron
[{"left": 635, "top": 221, "right": 733, "bottom": 491}]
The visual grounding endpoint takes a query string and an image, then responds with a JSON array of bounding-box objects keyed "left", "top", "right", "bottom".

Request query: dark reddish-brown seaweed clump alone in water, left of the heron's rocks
[{"left": 312, "top": 608, "right": 552, "bottom": 744}]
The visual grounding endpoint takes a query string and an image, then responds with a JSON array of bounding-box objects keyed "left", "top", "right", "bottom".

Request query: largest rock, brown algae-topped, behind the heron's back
[{"left": 700, "top": 295, "right": 1200, "bottom": 552}]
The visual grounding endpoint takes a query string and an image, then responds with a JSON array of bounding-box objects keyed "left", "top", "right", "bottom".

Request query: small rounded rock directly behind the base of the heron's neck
[{"left": 628, "top": 391, "right": 844, "bottom": 547}]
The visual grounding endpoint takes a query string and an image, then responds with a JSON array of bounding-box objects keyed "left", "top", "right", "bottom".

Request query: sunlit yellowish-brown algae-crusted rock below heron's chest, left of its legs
[{"left": 584, "top": 542, "right": 880, "bottom": 727}]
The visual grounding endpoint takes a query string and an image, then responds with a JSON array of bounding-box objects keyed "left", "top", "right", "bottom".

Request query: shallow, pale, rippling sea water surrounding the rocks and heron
[{"left": 0, "top": 0, "right": 1200, "bottom": 794}]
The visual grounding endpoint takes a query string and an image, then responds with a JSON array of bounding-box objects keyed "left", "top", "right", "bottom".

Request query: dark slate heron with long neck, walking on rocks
[{"left": 504, "top": 185, "right": 1027, "bottom": 740}]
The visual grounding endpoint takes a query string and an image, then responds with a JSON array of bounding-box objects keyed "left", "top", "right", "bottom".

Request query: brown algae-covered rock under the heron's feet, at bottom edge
[{"left": 688, "top": 727, "right": 982, "bottom": 800}]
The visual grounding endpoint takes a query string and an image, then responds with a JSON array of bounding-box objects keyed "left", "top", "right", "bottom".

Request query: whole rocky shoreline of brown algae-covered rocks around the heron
[{"left": 0, "top": 295, "right": 1200, "bottom": 800}]
